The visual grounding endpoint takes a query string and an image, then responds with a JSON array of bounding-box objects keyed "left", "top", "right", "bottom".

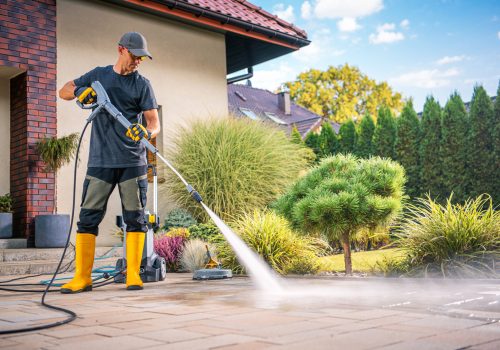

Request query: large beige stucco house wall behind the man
[{"left": 57, "top": 0, "right": 228, "bottom": 245}]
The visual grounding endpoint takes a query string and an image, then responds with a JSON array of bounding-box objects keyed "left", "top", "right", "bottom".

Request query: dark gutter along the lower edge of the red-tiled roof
[{"left": 152, "top": 0, "right": 311, "bottom": 47}]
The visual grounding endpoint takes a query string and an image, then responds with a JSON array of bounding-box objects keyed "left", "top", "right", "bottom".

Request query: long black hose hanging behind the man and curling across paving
[{"left": 0, "top": 120, "right": 90, "bottom": 335}]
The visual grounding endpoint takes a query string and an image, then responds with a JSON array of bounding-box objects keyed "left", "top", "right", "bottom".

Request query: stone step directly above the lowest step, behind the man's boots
[{"left": 0, "top": 247, "right": 123, "bottom": 264}]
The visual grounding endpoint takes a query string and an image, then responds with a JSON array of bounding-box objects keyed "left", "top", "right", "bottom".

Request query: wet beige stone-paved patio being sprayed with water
[{"left": 0, "top": 274, "right": 500, "bottom": 350}]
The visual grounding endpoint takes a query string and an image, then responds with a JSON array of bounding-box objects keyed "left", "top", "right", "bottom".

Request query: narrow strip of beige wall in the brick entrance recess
[{"left": 0, "top": 77, "right": 10, "bottom": 196}]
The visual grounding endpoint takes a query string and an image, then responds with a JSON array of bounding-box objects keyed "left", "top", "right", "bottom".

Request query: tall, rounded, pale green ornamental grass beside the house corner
[{"left": 160, "top": 118, "right": 306, "bottom": 222}]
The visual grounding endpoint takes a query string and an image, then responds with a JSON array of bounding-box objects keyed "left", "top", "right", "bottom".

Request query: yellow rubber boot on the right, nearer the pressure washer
[{"left": 127, "top": 232, "right": 146, "bottom": 290}]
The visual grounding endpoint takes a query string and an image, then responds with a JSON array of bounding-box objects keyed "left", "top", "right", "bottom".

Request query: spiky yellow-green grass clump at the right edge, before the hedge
[{"left": 399, "top": 196, "right": 500, "bottom": 277}]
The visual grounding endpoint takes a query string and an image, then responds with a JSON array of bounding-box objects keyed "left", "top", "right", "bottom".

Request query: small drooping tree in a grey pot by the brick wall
[{"left": 35, "top": 133, "right": 79, "bottom": 248}]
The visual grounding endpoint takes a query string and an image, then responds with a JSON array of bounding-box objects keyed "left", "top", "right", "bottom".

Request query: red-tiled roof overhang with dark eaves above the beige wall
[{"left": 109, "top": 0, "right": 310, "bottom": 74}]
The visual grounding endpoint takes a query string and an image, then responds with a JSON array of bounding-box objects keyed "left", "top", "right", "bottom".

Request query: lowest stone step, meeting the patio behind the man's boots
[{"left": 0, "top": 257, "right": 119, "bottom": 276}]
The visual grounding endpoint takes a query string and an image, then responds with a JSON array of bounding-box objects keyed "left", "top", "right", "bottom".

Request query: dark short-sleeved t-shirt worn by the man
[{"left": 74, "top": 66, "right": 158, "bottom": 168}]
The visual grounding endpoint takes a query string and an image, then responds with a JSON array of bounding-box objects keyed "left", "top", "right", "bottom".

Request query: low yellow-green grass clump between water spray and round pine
[{"left": 217, "top": 211, "right": 320, "bottom": 274}]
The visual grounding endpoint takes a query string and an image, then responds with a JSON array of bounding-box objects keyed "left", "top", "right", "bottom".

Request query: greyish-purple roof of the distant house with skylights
[{"left": 228, "top": 84, "right": 340, "bottom": 138}]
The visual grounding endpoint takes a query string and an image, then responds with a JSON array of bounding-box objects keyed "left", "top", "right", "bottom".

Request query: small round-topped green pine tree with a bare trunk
[{"left": 273, "top": 154, "right": 405, "bottom": 274}]
